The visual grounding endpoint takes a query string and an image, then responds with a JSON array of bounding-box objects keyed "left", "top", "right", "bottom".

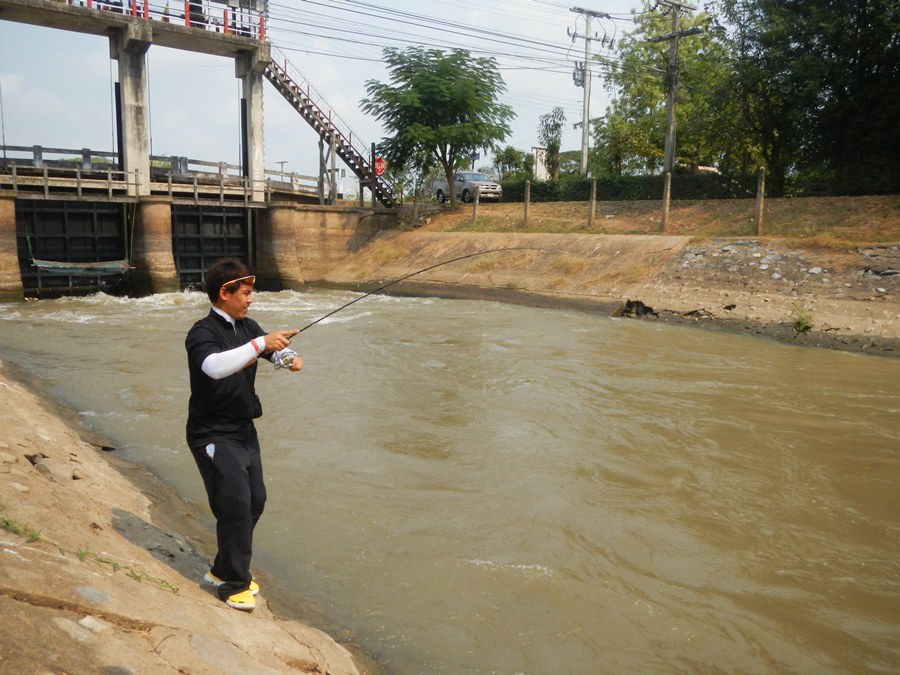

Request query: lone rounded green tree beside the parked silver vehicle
[{"left": 362, "top": 47, "right": 515, "bottom": 205}]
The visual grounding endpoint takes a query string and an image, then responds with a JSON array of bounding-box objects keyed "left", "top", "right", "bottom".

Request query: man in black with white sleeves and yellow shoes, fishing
[{"left": 185, "top": 258, "right": 303, "bottom": 610}]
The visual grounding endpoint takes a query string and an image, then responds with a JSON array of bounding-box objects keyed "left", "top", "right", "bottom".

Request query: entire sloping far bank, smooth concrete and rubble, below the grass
[{"left": 326, "top": 227, "right": 900, "bottom": 356}]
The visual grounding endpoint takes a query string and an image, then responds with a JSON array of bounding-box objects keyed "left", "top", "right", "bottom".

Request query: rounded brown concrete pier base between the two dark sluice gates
[{"left": 131, "top": 196, "right": 180, "bottom": 296}]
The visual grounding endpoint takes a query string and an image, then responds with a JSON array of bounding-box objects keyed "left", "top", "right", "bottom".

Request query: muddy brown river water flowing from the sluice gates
[{"left": 0, "top": 291, "right": 900, "bottom": 675}]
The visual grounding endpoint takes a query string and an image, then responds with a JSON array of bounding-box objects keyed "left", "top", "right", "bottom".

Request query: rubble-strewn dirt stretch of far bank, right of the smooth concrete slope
[{"left": 628, "top": 239, "right": 900, "bottom": 356}]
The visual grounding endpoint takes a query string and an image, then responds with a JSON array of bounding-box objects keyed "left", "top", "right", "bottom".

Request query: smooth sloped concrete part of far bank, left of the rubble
[{"left": 325, "top": 231, "right": 688, "bottom": 309}]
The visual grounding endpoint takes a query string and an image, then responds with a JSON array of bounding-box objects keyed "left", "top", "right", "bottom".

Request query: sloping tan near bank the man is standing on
[{"left": 0, "top": 361, "right": 362, "bottom": 675}]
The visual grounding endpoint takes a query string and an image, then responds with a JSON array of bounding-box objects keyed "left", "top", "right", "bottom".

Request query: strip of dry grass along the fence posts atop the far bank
[{"left": 424, "top": 195, "right": 900, "bottom": 252}]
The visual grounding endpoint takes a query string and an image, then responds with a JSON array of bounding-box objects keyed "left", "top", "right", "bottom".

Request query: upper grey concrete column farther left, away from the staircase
[{"left": 109, "top": 23, "right": 153, "bottom": 196}]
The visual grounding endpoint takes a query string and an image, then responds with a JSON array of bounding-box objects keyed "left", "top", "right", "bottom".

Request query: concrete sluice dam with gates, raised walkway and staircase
[{"left": 0, "top": 0, "right": 397, "bottom": 299}]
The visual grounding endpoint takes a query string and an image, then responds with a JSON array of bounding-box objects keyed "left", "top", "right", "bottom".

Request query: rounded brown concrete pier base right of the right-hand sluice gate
[{"left": 256, "top": 204, "right": 305, "bottom": 290}]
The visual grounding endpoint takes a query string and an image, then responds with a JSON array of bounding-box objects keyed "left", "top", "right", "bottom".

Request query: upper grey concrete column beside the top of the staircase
[{"left": 234, "top": 43, "right": 272, "bottom": 202}]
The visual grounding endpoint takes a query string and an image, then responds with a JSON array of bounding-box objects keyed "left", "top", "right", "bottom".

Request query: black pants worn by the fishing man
[{"left": 190, "top": 425, "right": 266, "bottom": 600}]
